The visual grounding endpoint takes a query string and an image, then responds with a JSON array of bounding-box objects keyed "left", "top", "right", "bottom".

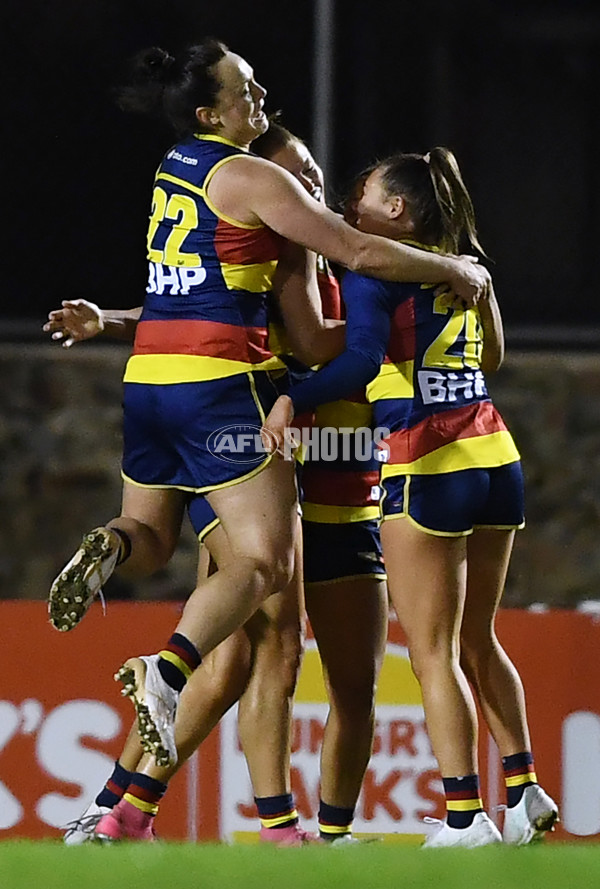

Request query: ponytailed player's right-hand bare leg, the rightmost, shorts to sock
[{"left": 461, "top": 529, "right": 531, "bottom": 756}]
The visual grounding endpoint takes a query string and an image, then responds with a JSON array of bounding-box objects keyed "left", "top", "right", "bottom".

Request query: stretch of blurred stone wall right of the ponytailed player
[{"left": 489, "top": 352, "right": 600, "bottom": 607}]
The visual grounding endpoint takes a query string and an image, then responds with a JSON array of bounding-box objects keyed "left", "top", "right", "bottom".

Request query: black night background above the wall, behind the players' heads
[{"left": 0, "top": 0, "right": 600, "bottom": 334}]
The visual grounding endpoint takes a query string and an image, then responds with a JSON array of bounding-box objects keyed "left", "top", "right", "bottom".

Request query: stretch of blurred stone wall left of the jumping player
[{"left": 0, "top": 344, "right": 197, "bottom": 599}]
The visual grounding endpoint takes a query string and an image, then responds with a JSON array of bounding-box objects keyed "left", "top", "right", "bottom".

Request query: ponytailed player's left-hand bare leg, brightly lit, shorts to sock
[{"left": 381, "top": 518, "right": 478, "bottom": 776}]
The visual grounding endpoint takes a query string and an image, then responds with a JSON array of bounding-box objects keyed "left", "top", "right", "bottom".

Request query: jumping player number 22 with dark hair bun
[{"left": 45, "top": 39, "right": 490, "bottom": 784}]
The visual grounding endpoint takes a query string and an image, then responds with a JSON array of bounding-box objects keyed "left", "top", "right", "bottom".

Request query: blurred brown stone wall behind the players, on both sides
[{"left": 0, "top": 343, "right": 600, "bottom": 607}]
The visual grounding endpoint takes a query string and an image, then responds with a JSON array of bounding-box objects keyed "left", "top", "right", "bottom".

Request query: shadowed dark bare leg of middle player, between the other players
[{"left": 305, "top": 578, "right": 388, "bottom": 808}]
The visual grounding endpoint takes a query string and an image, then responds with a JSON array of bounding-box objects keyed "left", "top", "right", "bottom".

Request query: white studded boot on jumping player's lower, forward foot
[{"left": 115, "top": 654, "right": 179, "bottom": 766}]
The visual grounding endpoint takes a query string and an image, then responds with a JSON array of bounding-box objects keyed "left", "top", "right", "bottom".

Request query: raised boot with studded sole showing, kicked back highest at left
[{"left": 48, "top": 528, "right": 120, "bottom": 633}]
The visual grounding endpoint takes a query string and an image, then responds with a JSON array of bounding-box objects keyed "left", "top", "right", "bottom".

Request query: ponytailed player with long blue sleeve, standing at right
[{"left": 265, "top": 148, "right": 558, "bottom": 847}]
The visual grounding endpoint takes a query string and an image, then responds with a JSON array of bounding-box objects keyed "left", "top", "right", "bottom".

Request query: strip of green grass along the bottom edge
[{"left": 0, "top": 840, "right": 600, "bottom": 889}]
